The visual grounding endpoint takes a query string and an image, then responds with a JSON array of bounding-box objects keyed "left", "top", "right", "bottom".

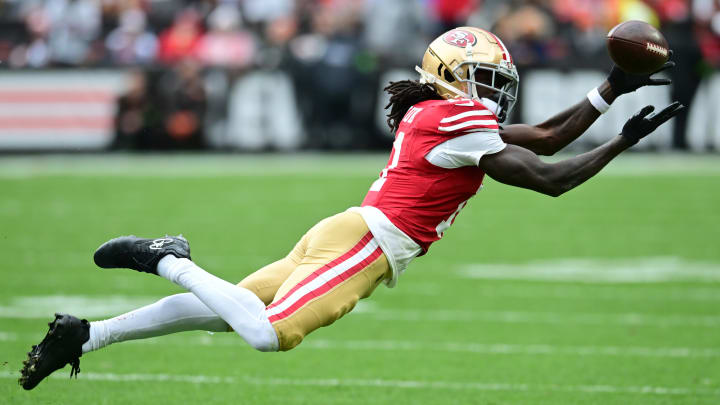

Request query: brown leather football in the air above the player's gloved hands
[{"left": 607, "top": 20, "right": 670, "bottom": 74}]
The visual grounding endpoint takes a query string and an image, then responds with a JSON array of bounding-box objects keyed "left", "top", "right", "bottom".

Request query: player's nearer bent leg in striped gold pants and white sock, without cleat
[{"left": 129, "top": 212, "right": 390, "bottom": 351}]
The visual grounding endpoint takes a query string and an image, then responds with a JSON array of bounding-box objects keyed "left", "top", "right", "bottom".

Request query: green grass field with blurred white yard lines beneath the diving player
[{"left": 0, "top": 155, "right": 720, "bottom": 405}]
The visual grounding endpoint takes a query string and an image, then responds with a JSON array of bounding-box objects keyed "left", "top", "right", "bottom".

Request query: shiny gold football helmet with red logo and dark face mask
[{"left": 415, "top": 27, "right": 520, "bottom": 122}]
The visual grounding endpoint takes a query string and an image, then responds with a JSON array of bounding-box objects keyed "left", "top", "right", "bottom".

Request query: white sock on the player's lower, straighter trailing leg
[{"left": 82, "top": 293, "right": 228, "bottom": 353}]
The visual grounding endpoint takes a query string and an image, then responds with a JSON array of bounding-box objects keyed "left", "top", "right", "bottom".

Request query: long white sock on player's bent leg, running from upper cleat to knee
[{"left": 157, "top": 255, "right": 278, "bottom": 351}]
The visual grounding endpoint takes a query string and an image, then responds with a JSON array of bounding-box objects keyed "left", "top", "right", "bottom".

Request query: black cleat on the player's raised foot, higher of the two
[{"left": 94, "top": 235, "right": 190, "bottom": 274}]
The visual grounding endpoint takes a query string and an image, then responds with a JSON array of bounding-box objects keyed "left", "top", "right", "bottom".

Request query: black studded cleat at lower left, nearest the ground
[{"left": 18, "top": 314, "right": 90, "bottom": 390}]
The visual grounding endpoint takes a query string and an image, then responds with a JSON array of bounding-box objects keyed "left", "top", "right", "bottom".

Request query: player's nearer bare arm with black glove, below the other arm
[{"left": 479, "top": 102, "right": 683, "bottom": 197}]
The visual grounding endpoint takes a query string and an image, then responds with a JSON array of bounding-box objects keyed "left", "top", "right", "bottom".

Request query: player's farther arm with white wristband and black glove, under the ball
[{"left": 500, "top": 61, "right": 675, "bottom": 155}]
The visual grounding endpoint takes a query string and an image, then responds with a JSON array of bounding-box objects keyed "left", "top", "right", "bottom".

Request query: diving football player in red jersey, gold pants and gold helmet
[{"left": 19, "top": 27, "right": 683, "bottom": 390}]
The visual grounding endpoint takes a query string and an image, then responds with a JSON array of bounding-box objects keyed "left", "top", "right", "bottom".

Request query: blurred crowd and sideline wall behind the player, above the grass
[{"left": 0, "top": 0, "right": 720, "bottom": 152}]
